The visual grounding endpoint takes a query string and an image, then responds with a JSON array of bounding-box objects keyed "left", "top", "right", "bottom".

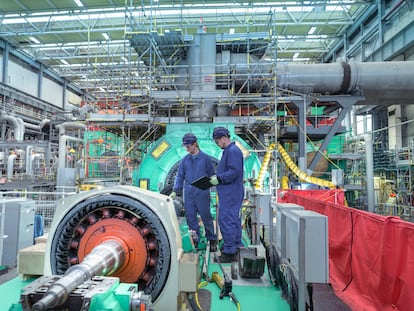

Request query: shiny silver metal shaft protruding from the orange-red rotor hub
[{"left": 32, "top": 240, "right": 125, "bottom": 311}]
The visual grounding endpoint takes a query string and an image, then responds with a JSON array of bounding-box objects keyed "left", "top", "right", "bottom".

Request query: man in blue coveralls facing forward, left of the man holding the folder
[{"left": 170, "top": 133, "right": 217, "bottom": 252}]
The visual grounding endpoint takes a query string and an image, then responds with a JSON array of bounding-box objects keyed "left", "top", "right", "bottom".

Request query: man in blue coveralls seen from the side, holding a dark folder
[{"left": 210, "top": 126, "right": 244, "bottom": 263}]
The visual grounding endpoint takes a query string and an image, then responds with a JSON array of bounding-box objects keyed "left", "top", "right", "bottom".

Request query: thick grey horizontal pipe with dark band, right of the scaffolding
[{"left": 276, "top": 61, "right": 414, "bottom": 105}]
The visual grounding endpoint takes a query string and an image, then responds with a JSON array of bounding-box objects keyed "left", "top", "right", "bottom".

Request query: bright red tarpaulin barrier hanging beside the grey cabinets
[{"left": 278, "top": 189, "right": 414, "bottom": 311}]
